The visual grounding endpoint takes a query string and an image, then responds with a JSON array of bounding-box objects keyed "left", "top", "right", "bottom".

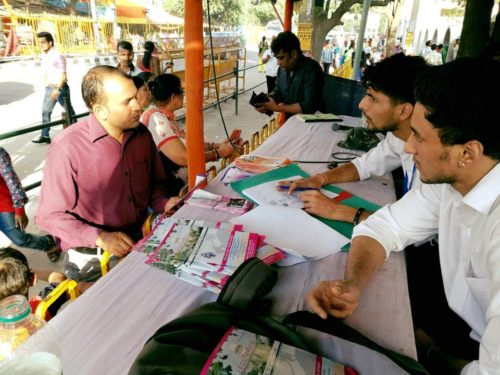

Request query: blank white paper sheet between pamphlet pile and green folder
[{"left": 230, "top": 205, "right": 349, "bottom": 259}]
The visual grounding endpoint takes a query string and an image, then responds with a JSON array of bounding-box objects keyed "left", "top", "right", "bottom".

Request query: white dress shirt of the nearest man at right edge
[{"left": 353, "top": 164, "right": 500, "bottom": 374}]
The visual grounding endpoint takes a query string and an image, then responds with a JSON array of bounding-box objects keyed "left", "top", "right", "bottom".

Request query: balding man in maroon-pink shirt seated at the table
[{"left": 35, "top": 66, "right": 176, "bottom": 281}]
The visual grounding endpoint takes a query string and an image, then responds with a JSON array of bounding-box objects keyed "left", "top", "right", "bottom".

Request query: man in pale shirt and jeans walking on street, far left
[{"left": 31, "top": 31, "right": 75, "bottom": 143}]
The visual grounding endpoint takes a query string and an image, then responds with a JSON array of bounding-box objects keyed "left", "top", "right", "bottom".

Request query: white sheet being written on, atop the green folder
[{"left": 243, "top": 176, "right": 338, "bottom": 208}]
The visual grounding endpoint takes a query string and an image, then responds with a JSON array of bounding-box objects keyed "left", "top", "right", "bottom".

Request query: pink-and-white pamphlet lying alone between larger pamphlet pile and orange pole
[{"left": 185, "top": 189, "right": 253, "bottom": 214}]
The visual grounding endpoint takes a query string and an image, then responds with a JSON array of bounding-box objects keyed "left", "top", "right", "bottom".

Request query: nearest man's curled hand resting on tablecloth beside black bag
[{"left": 306, "top": 280, "right": 361, "bottom": 319}]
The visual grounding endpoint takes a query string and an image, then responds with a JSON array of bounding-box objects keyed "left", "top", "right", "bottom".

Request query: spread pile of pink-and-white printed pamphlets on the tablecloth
[{"left": 134, "top": 218, "right": 284, "bottom": 293}]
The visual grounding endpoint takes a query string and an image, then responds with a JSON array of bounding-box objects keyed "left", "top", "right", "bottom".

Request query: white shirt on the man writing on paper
[{"left": 352, "top": 132, "right": 420, "bottom": 190}]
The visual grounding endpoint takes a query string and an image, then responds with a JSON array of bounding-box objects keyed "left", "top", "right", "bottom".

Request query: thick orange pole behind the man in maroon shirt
[{"left": 184, "top": 0, "right": 205, "bottom": 188}]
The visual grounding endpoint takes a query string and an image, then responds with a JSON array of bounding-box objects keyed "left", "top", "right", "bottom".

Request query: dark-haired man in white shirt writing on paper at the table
[{"left": 280, "top": 53, "right": 427, "bottom": 223}]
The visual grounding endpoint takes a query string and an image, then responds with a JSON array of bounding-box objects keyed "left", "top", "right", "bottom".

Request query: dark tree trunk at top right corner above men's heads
[{"left": 457, "top": 0, "right": 498, "bottom": 57}]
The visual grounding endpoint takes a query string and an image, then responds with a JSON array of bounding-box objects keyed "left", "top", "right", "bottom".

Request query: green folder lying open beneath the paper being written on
[{"left": 231, "top": 164, "right": 380, "bottom": 245}]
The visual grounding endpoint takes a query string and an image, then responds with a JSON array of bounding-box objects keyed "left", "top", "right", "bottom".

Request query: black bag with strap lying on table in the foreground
[{"left": 129, "top": 258, "right": 427, "bottom": 375}]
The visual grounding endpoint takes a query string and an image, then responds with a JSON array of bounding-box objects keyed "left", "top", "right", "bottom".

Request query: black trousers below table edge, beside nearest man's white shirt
[{"left": 406, "top": 242, "right": 479, "bottom": 360}]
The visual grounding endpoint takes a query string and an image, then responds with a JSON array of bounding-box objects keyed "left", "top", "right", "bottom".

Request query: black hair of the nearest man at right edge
[{"left": 415, "top": 57, "right": 500, "bottom": 160}]
